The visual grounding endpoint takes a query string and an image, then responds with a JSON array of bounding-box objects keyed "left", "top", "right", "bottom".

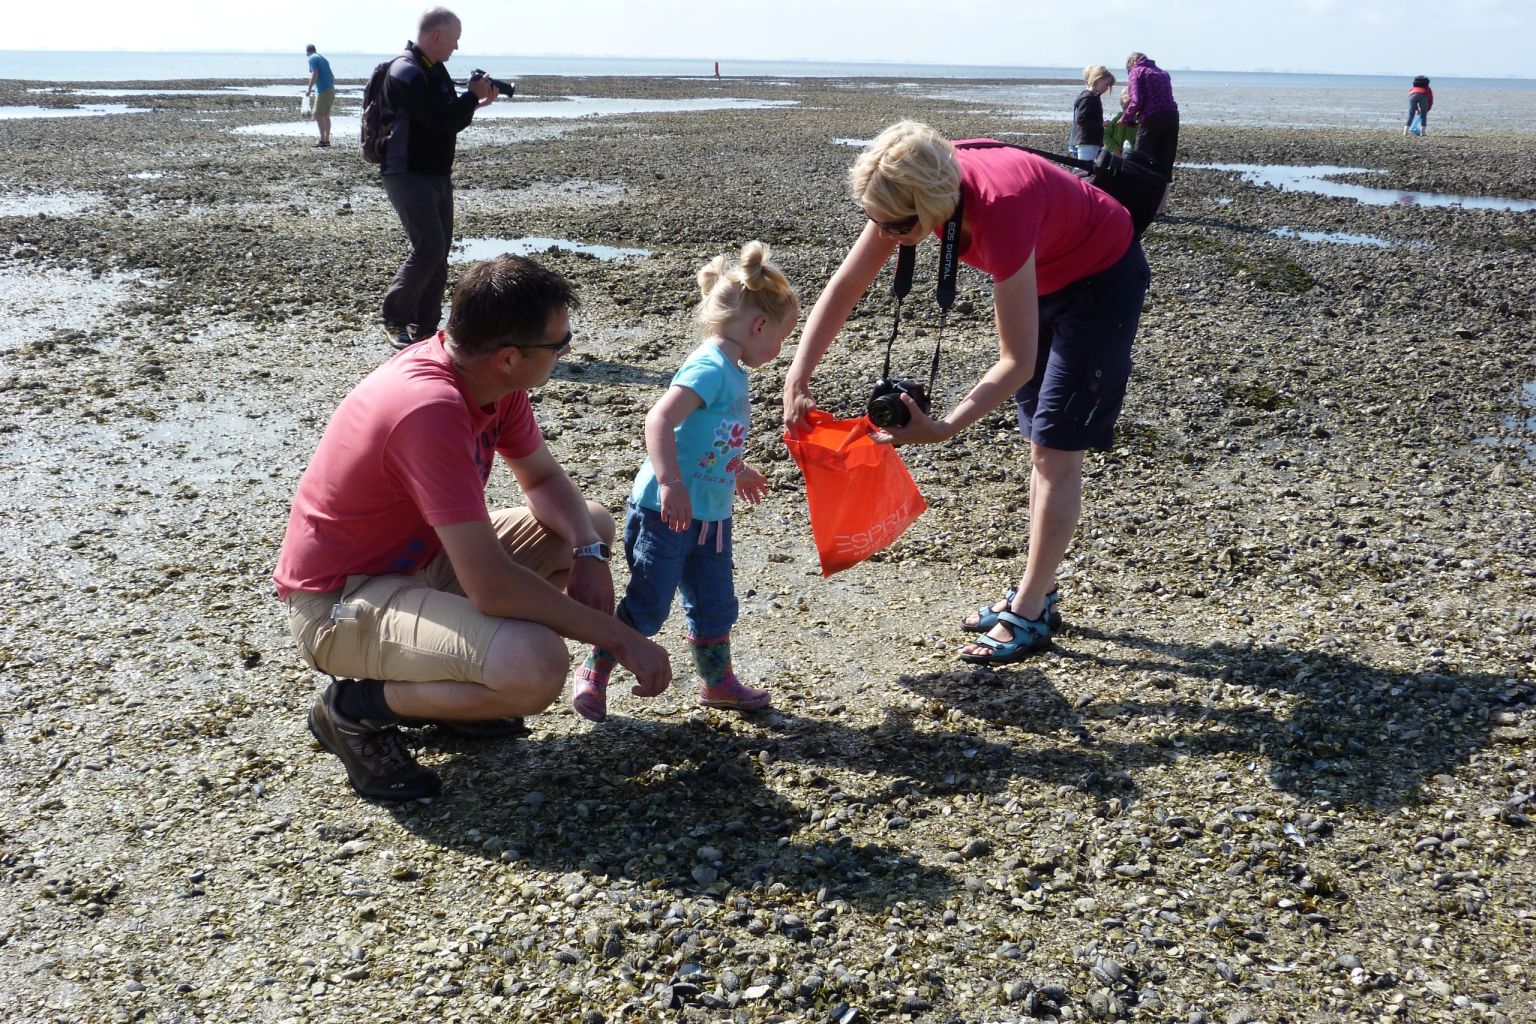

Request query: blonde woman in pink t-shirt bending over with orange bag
[{"left": 783, "top": 121, "right": 1152, "bottom": 663}]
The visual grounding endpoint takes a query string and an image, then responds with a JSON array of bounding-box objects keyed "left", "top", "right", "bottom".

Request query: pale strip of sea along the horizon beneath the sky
[{"left": 0, "top": 51, "right": 1536, "bottom": 132}]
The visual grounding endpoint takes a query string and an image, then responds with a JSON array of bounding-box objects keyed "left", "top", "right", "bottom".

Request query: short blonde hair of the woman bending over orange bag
[{"left": 848, "top": 121, "right": 960, "bottom": 230}]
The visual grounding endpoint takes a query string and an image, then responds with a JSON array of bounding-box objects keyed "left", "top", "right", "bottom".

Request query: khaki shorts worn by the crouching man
[{"left": 283, "top": 508, "right": 570, "bottom": 683}]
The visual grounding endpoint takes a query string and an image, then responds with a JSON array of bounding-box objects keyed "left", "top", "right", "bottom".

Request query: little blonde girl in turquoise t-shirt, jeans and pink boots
[{"left": 571, "top": 241, "right": 800, "bottom": 722}]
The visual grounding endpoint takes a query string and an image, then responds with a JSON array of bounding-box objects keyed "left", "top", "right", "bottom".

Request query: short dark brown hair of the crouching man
[{"left": 449, "top": 253, "right": 581, "bottom": 356}]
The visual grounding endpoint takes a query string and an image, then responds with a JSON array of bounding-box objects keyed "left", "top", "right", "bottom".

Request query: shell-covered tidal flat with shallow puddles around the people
[{"left": 0, "top": 78, "right": 1536, "bottom": 1024}]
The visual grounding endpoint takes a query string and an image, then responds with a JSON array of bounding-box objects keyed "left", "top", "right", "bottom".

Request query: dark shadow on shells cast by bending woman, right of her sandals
[{"left": 902, "top": 628, "right": 1531, "bottom": 809}]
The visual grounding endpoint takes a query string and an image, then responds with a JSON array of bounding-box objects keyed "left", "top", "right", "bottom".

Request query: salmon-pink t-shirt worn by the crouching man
[{"left": 272, "top": 333, "right": 544, "bottom": 599}]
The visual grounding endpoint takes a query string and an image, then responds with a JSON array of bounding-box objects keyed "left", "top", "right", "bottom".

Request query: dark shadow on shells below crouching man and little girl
[{"left": 392, "top": 712, "right": 957, "bottom": 907}]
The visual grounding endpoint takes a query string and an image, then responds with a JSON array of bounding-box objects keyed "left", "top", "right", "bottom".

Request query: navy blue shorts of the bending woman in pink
[{"left": 1014, "top": 241, "right": 1152, "bottom": 451}]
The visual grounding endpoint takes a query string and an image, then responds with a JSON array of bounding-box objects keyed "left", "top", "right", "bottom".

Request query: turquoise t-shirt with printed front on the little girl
[{"left": 630, "top": 341, "right": 751, "bottom": 522}]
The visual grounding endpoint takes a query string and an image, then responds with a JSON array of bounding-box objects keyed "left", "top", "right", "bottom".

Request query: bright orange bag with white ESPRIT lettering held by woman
[{"left": 783, "top": 408, "right": 928, "bottom": 576}]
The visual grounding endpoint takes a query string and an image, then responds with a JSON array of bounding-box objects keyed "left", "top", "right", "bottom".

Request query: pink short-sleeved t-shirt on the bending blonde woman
[{"left": 935, "top": 138, "right": 1134, "bottom": 295}]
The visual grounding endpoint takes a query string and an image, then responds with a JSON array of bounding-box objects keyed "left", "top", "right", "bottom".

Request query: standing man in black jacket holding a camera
[{"left": 381, "top": 8, "right": 496, "bottom": 348}]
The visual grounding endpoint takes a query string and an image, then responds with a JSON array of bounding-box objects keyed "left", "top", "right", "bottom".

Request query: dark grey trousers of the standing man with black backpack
[{"left": 381, "top": 173, "right": 453, "bottom": 333}]
